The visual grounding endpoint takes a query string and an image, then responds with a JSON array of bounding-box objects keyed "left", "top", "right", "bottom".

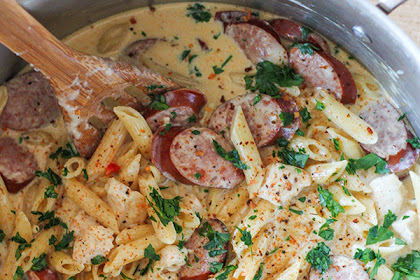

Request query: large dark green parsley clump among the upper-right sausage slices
[{"left": 244, "top": 61, "right": 303, "bottom": 97}]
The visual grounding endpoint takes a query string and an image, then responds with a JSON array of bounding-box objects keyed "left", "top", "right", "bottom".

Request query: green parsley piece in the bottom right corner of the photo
[{"left": 391, "top": 250, "right": 420, "bottom": 280}]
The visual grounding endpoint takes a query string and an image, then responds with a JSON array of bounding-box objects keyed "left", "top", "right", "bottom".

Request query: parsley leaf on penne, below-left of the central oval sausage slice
[{"left": 147, "top": 188, "right": 181, "bottom": 226}]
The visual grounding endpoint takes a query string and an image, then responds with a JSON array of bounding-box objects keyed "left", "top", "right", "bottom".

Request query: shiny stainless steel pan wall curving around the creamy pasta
[{"left": 0, "top": 0, "right": 420, "bottom": 135}]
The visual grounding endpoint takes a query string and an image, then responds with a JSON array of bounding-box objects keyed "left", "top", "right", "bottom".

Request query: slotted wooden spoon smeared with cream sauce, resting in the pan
[{"left": 0, "top": 0, "right": 178, "bottom": 158}]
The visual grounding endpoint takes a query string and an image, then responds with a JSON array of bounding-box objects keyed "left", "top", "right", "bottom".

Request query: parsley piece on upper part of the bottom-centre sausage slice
[{"left": 198, "top": 222, "right": 230, "bottom": 257}]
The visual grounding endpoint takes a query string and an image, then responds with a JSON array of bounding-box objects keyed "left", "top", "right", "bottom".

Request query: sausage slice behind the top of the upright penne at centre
[{"left": 208, "top": 93, "right": 301, "bottom": 147}]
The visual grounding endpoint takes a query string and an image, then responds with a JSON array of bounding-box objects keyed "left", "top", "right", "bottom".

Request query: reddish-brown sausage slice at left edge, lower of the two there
[{"left": 0, "top": 137, "right": 39, "bottom": 193}]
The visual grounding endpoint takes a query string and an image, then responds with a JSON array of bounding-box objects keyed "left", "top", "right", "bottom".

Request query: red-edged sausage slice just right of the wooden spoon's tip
[{"left": 143, "top": 88, "right": 207, "bottom": 131}]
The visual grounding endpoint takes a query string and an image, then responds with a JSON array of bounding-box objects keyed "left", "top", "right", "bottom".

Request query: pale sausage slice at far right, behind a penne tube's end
[{"left": 359, "top": 98, "right": 408, "bottom": 160}]
